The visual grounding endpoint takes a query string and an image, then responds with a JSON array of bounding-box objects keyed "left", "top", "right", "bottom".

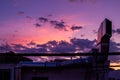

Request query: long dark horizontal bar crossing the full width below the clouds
[{"left": 0, "top": 52, "right": 120, "bottom": 56}]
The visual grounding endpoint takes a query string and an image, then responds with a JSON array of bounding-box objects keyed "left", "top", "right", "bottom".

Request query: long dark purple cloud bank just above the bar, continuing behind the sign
[{"left": 0, "top": 38, "right": 120, "bottom": 53}]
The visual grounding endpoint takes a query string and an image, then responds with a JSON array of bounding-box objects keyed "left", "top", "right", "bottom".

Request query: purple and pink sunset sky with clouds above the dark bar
[{"left": 0, "top": 0, "right": 120, "bottom": 53}]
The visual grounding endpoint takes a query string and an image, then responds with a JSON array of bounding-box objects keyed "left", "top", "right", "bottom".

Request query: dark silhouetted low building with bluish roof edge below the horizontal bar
[{"left": 0, "top": 58, "right": 109, "bottom": 80}]
